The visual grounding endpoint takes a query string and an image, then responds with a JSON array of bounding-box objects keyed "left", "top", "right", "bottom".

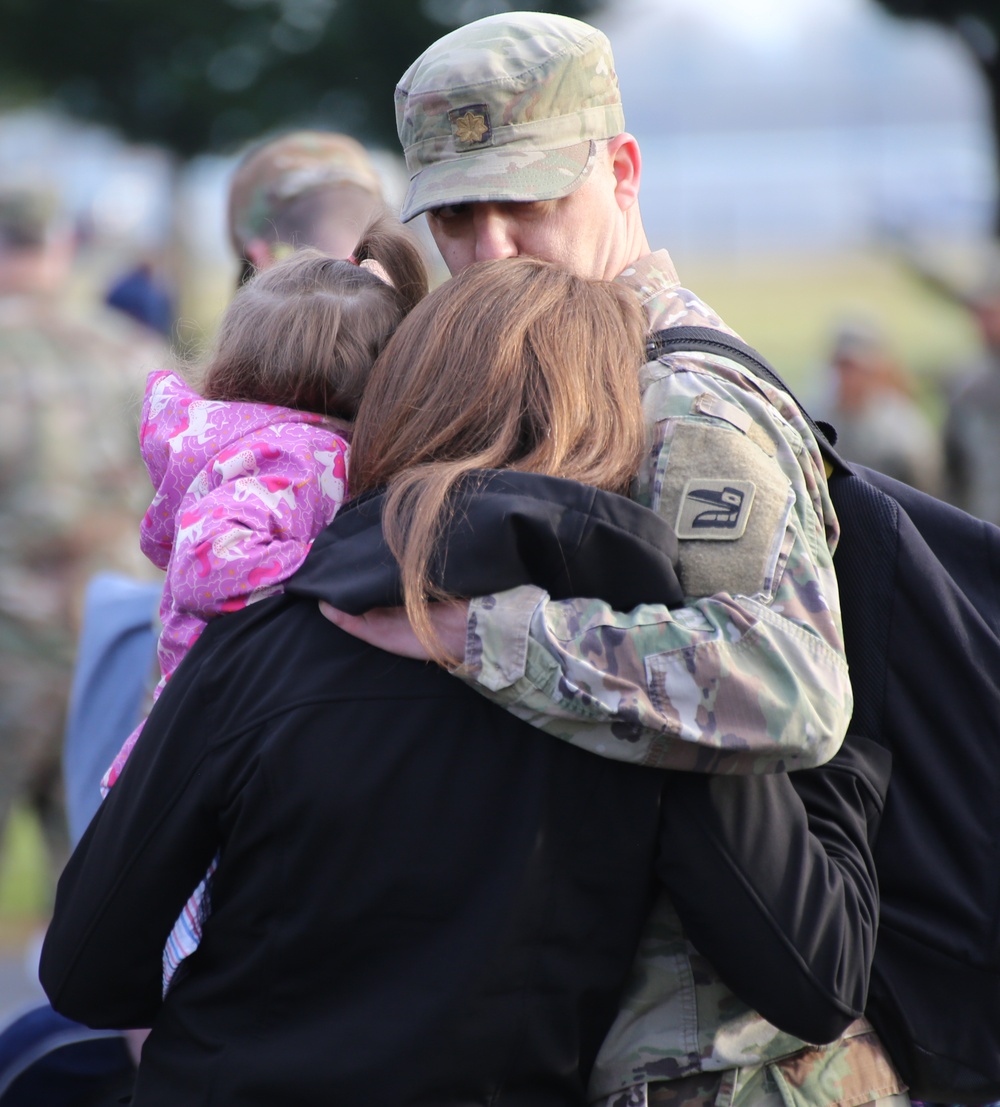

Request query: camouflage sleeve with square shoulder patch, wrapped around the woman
[{"left": 461, "top": 355, "right": 852, "bottom": 773}]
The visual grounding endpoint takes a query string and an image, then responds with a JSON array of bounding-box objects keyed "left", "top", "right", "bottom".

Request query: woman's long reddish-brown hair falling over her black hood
[{"left": 350, "top": 258, "right": 647, "bottom": 664}]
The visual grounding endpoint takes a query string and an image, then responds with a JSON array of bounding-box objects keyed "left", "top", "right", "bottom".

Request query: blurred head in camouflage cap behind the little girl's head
[{"left": 229, "top": 131, "right": 384, "bottom": 283}]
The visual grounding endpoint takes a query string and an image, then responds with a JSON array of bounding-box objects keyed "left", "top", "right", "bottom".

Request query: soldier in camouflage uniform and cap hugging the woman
[{"left": 327, "top": 12, "right": 906, "bottom": 1107}]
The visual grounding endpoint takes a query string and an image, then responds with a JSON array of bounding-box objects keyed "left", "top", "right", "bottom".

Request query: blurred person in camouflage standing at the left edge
[{"left": 0, "top": 188, "right": 167, "bottom": 885}]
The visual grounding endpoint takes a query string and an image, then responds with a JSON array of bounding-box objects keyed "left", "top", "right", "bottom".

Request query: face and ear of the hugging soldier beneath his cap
[{"left": 427, "top": 146, "right": 623, "bottom": 280}]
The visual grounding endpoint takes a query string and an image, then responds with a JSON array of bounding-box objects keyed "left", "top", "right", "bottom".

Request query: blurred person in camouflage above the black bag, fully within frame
[{"left": 829, "top": 319, "right": 944, "bottom": 496}]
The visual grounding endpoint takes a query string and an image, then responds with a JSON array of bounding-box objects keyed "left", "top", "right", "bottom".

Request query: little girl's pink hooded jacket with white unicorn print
[{"left": 140, "top": 371, "right": 348, "bottom": 679}]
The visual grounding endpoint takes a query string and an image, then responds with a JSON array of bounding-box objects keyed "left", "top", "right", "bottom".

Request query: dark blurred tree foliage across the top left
[{"left": 0, "top": 0, "right": 602, "bottom": 157}]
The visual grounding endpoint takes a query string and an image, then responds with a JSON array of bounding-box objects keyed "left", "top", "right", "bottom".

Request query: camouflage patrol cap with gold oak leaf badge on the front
[{"left": 395, "top": 11, "right": 625, "bottom": 223}]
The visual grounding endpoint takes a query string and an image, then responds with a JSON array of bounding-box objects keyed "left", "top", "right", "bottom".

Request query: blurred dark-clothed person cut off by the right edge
[{"left": 945, "top": 270, "right": 1000, "bottom": 524}]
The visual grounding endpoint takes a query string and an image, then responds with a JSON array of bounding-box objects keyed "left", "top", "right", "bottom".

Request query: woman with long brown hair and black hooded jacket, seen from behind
[{"left": 41, "top": 259, "right": 874, "bottom": 1107}]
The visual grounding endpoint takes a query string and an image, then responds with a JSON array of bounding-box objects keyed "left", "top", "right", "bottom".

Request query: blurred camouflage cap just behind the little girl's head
[{"left": 229, "top": 131, "right": 382, "bottom": 254}]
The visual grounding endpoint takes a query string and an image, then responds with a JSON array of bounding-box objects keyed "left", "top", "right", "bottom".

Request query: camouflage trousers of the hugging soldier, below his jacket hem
[{"left": 591, "top": 1020, "right": 910, "bottom": 1107}]
